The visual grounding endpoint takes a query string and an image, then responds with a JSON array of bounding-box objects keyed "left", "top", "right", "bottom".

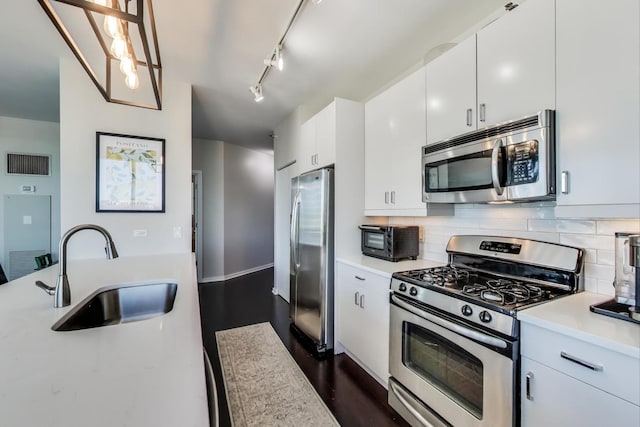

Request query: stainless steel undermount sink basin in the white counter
[{"left": 51, "top": 282, "right": 178, "bottom": 331}]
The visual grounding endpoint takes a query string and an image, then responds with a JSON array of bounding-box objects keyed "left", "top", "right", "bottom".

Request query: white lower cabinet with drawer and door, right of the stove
[{"left": 520, "top": 322, "right": 640, "bottom": 427}]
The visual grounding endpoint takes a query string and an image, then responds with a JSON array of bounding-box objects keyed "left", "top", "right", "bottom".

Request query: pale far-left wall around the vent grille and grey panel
[{"left": 0, "top": 117, "right": 60, "bottom": 272}]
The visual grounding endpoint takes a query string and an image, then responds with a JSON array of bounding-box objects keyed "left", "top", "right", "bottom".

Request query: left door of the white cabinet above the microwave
[{"left": 426, "top": 34, "right": 477, "bottom": 144}]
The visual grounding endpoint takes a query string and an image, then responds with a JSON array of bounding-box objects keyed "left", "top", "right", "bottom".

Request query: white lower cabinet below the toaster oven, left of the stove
[{"left": 335, "top": 261, "right": 391, "bottom": 387}]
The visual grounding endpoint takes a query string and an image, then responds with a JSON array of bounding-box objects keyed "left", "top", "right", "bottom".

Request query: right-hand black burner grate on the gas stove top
[{"left": 462, "top": 279, "right": 542, "bottom": 305}]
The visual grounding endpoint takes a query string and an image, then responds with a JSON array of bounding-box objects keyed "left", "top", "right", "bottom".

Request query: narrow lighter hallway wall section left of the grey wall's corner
[{"left": 192, "top": 139, "right": 224, "bottom": 282}]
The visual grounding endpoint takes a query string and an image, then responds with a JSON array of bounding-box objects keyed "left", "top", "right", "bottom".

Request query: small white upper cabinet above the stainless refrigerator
[{"left": 298, "top": 102, "right": 336, "bottom": 173}]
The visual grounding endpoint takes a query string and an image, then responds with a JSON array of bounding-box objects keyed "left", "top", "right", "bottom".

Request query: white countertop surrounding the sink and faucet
[{"left": 0, "top": 254, "right": 208, "bottom": 427}]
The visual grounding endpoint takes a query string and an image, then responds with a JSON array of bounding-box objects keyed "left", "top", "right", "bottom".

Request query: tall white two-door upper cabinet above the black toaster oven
[{"left": 365, "top": 67, "right": 452, "bottom": 216}]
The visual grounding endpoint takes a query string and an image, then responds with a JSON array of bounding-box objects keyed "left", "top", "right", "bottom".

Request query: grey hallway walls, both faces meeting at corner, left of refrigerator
[{"left": 193, "top": 139, "right": 274, "bottom": 282}]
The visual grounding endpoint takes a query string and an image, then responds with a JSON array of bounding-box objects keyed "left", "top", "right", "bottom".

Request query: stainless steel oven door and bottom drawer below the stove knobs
[{"left": 389, "top": 295, "right": 518, "bottom": 427}]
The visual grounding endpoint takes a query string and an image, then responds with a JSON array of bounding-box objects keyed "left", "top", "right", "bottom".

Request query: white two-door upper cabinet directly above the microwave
[{"left": 426, "top": 0, "right": 556, "bottom": 144}]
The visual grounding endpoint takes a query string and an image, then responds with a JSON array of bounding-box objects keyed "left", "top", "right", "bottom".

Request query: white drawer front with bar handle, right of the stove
[{"left": 520, "top": 323, "right": 640, "bottom": 405}]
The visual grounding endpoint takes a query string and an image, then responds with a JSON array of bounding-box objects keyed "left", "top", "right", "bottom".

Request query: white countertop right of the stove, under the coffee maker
[{"left": 518, "top": 292, "right": 640, "bottom": 360}]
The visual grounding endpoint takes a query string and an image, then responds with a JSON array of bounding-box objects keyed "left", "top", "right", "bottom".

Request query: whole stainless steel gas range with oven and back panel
[{"left": 388, "top": 236, "right": 583, "bottom": 427}]
